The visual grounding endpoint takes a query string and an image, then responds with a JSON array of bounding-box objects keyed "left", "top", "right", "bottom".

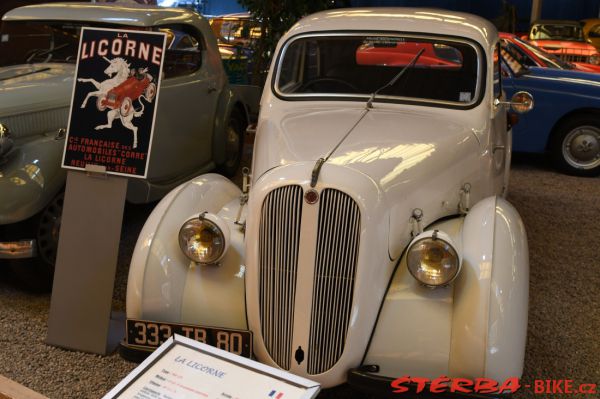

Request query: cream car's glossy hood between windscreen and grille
[{"left": 254, "top": 105, "right": 484, "bottom": 190}]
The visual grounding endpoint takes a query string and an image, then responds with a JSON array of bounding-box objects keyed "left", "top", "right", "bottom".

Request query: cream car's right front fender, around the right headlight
[{"left": 363, "top": 197, "right": 529, "bottom": 381}]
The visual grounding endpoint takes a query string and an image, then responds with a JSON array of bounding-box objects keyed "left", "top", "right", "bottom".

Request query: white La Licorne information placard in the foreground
[{"left": 104, "top": 335, "right": 320, "bottom": 399}]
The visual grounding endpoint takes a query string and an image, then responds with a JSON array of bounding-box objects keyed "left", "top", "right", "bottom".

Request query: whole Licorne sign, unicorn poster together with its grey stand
[{"left": 46, "top": 28, "right": 166, "bottom": 354}]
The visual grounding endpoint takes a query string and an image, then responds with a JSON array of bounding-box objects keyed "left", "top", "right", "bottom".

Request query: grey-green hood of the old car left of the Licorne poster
[{"left": 0, "top": 63, "right": 75, "bottom": 118}]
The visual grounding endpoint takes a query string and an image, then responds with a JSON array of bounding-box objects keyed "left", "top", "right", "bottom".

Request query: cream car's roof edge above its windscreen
[{"left": 286, "top": 7, "right": 498, "bottom": 48}]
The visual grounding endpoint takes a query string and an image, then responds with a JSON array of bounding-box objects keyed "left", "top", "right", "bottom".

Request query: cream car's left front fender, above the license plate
[{"left": 127, "top": 174, "right": 247, "bottom": 329}]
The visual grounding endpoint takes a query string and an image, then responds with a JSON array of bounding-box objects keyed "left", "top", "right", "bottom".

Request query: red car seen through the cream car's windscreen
[{"left": 356, "top": 41, "right": 462, "bottom": 68}]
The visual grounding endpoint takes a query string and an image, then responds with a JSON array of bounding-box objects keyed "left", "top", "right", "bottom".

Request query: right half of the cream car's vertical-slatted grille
[{"left": 308, "top": 189, "right": 360, "bottom": 375}]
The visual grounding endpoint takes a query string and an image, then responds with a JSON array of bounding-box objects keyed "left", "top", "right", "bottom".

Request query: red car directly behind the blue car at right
[{"left": 500, "top": 32, "right": 600, "bottom": 72}]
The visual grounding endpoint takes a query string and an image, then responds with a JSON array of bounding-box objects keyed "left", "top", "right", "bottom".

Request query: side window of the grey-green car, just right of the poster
[{"left": 159, "top": 25, "right": 204, "bottom": 79}]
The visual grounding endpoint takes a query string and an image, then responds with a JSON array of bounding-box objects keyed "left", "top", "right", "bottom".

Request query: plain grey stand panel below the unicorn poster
[{"left": 46, "top": 165, "right": 127, "bottom": 355}]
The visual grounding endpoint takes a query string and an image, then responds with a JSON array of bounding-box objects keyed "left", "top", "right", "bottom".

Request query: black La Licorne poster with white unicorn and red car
[{"left": 62, "top": 28, "right": 166, "bottom": 178}]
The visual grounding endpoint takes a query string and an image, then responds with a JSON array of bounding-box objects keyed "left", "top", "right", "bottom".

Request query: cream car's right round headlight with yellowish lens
[{"left": 406, "top": 231, "right": 461, "bottom": 287}]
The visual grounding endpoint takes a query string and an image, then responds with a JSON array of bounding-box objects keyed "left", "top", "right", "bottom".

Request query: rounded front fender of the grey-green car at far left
[{"left": 0, "top": 132, "right": 66, "bottom": 224}]
